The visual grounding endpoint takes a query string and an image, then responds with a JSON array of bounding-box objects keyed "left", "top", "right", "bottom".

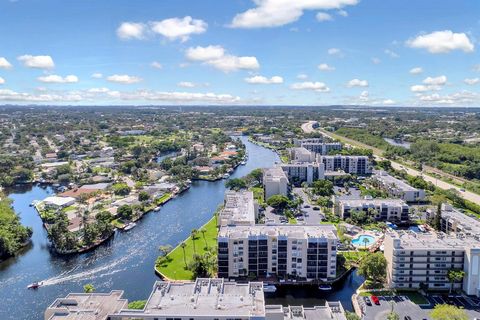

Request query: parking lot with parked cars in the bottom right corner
[{"left": 358, "top": 295, "right": 480, "bottom": 320}]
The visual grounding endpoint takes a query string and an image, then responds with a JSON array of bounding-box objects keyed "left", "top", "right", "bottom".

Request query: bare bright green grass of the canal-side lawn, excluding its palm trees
[{"left": 155, "top": 217, "right": 218, "bottom": 280}]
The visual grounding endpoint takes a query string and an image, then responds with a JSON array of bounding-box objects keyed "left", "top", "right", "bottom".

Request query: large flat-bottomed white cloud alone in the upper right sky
[{"left": 406, "top": 30, "right": 475, "bottom": 53}]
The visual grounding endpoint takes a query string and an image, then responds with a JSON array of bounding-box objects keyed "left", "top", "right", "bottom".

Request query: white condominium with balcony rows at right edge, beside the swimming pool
[{"left": 384, "top": 231, "right": 480, "bottom": 296}]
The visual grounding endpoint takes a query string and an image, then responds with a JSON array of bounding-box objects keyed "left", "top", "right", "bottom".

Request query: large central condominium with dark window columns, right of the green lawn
[{"left": 218, "top": 225, "right": 338, "bottom": 281}]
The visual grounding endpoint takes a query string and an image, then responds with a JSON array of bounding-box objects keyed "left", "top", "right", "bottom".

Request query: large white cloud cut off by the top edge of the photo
[{"left": 231, "top": 0, "right": 359, "bottom": 28}]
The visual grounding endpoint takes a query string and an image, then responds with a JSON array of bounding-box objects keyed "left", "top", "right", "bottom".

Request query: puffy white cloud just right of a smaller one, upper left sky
[{"left": 151, "top": 16, "right": 208, "bottom": 42}]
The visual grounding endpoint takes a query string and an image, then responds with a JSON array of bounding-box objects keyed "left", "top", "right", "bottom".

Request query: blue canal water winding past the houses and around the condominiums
[{"left": 0, "top": 137, "right": 360, "bottom": 320}]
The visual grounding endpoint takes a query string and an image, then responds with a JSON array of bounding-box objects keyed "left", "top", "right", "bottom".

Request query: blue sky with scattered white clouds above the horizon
[{"left": 0, "top": 0, "right": 480, "bottom": 106}]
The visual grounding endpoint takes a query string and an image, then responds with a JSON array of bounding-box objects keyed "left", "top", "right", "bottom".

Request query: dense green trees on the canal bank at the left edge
[{"left": 0, "top": 192, "right": 32, "bottom": 261}]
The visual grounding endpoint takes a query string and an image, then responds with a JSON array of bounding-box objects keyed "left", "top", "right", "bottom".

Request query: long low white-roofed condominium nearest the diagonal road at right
[{"left": 373, "top": 171, "right": 425, "bottom": 202}]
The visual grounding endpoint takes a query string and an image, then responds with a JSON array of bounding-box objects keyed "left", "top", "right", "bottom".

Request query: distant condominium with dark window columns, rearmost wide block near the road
[{"left": 317, "top": 155, "right": 372, "bottom": 175}]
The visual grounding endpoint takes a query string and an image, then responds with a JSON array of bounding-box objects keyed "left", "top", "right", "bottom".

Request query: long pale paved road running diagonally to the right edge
[{"left": 302, "top": 121, "right": 480, "bottom": 204}]
